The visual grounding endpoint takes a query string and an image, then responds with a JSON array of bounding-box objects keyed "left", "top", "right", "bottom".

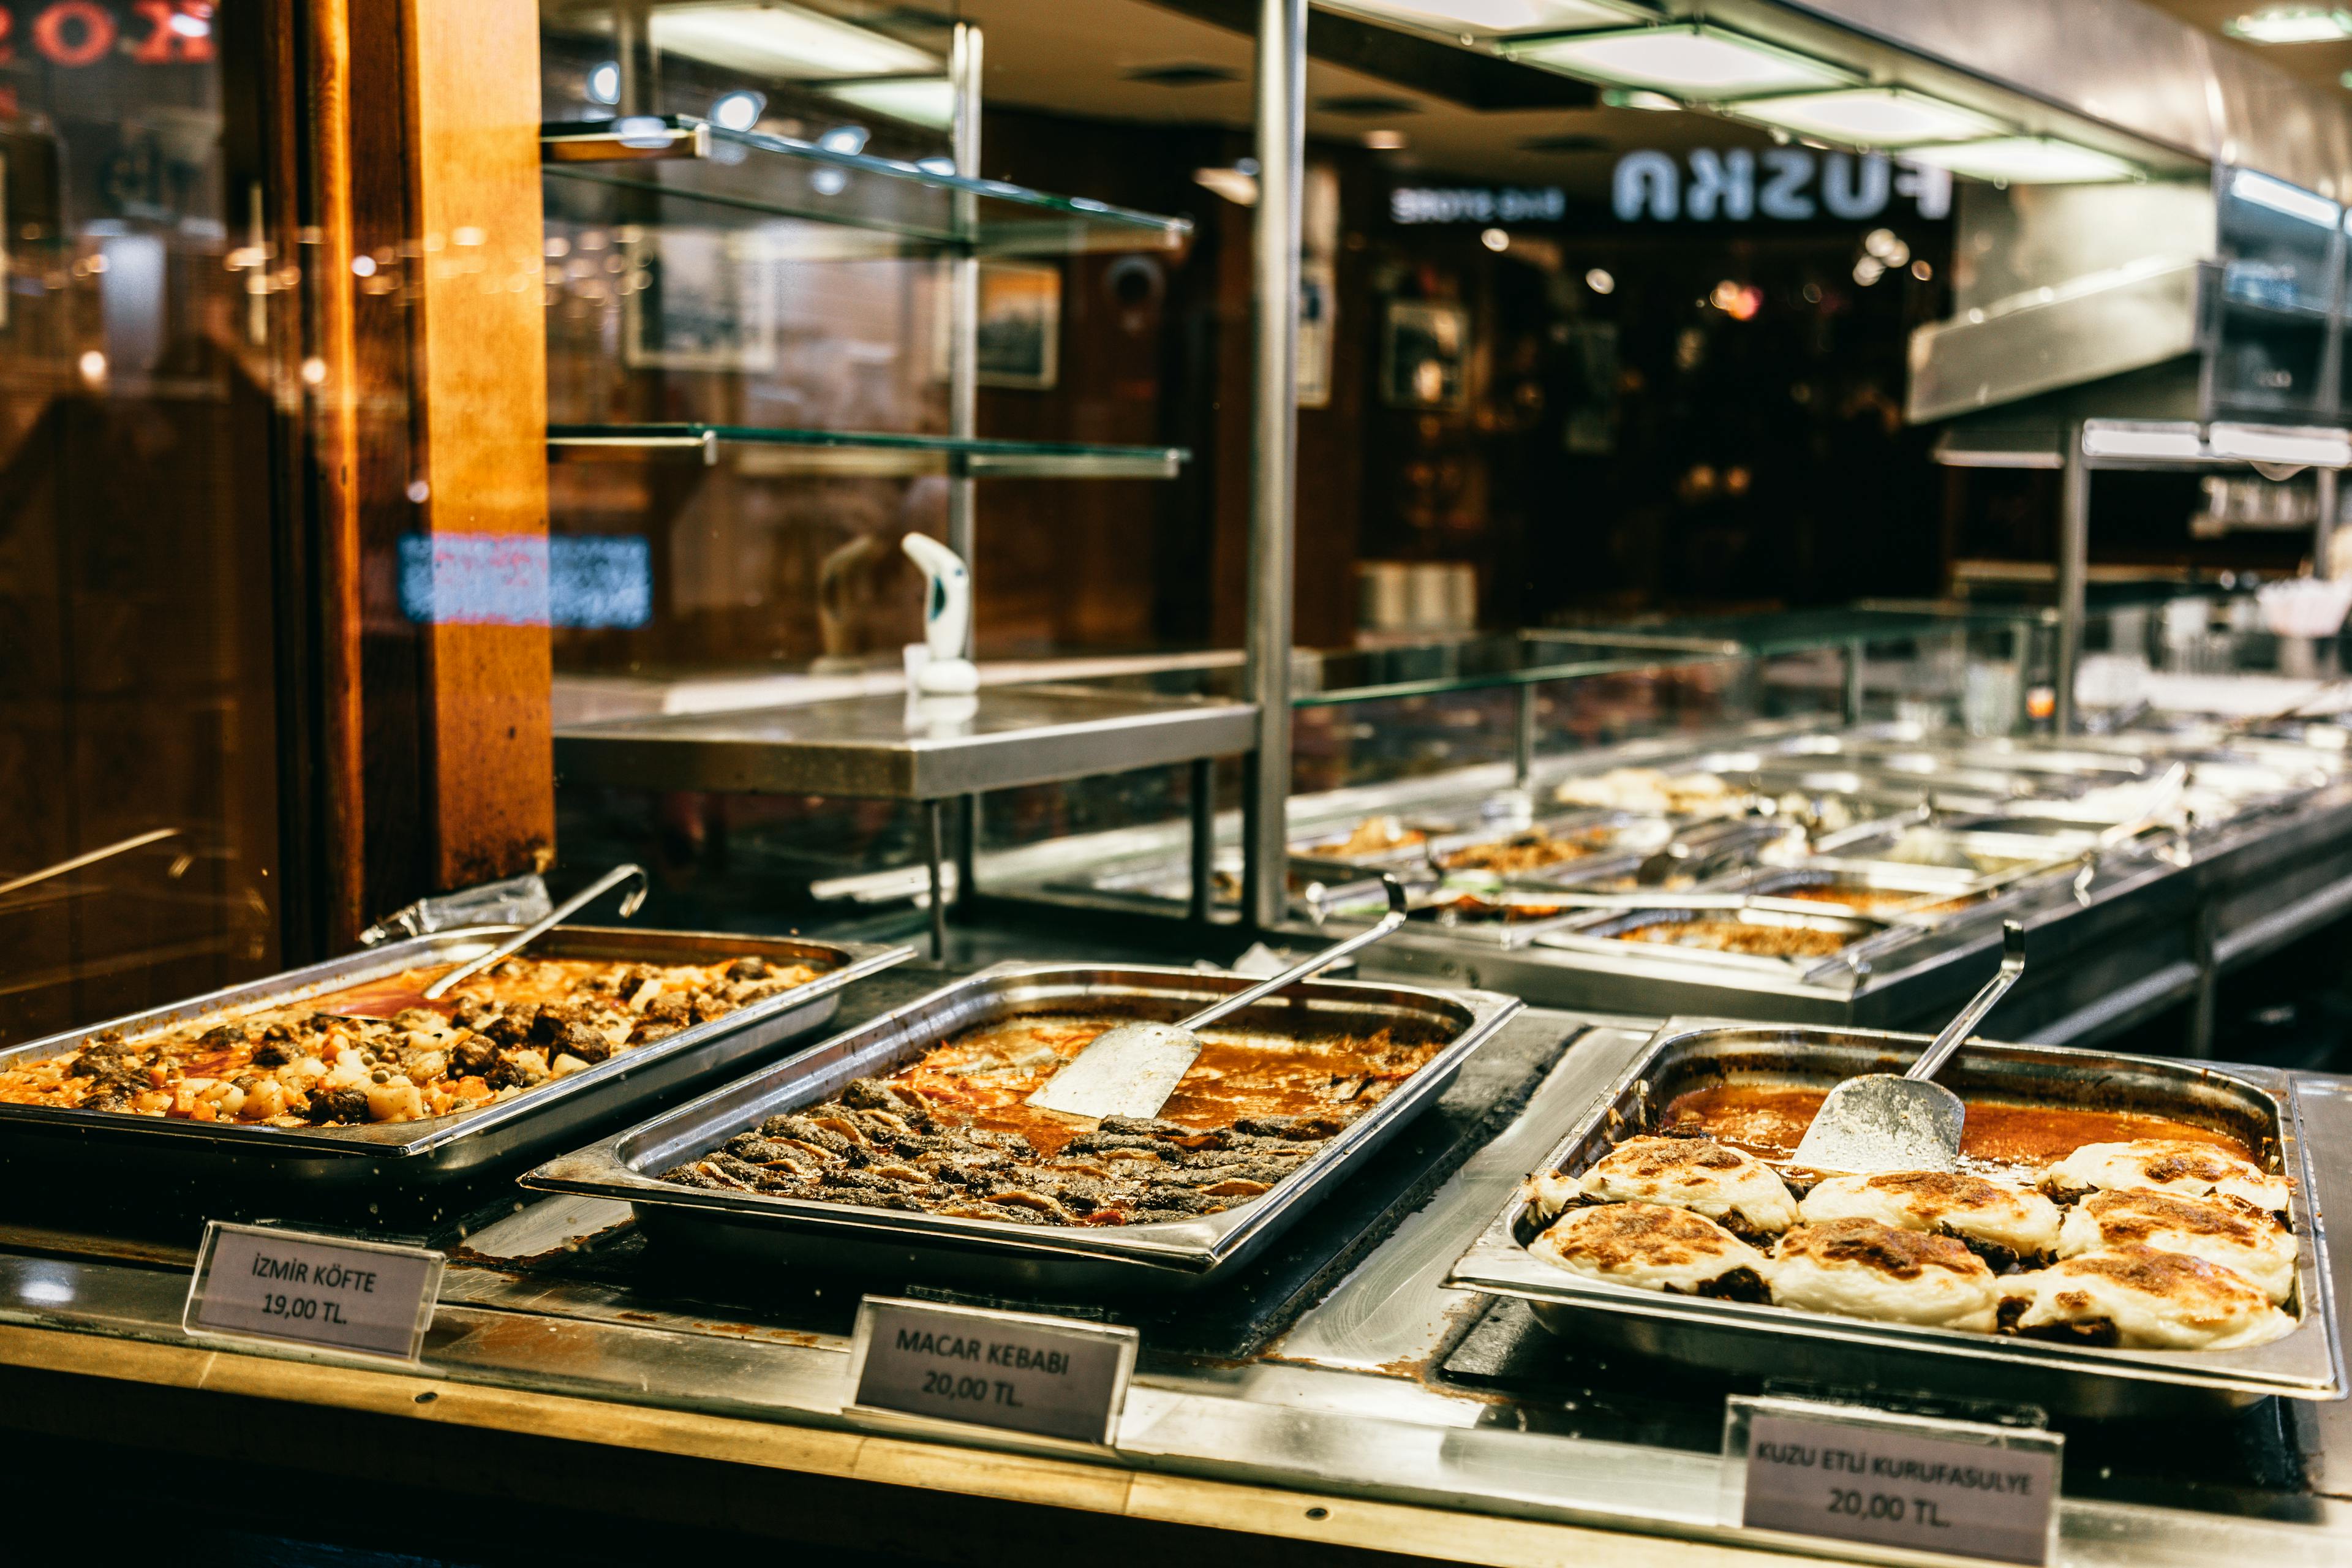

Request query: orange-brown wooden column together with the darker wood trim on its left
[{"left": 306, "top": 0, "right": 555, "bottom": 948}]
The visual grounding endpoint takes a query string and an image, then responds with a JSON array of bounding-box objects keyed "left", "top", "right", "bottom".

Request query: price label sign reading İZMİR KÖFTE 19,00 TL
[{"left": 181, "top": 1220, "right": 442, "bottom": 1361}]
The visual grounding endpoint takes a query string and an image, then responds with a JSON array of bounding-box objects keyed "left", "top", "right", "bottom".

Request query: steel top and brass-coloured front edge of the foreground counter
[{"left": 0, "top": 992, "right": 2352, "bottom": 1568}]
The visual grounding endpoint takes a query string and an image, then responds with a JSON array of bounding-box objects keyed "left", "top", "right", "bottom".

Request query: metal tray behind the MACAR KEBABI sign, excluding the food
[{"left": 522, "top": 964, "right": 1521, "bottom": 1298}]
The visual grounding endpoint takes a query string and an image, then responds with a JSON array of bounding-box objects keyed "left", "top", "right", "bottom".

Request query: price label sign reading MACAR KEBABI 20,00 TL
[{"left": 849, "top": 1295, "right": 1139, "bottom": 1444}]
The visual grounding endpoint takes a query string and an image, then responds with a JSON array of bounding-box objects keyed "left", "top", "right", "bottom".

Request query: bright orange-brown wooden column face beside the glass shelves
[{"left": 407, "top": 0, "right": 555, "bottom": 889}]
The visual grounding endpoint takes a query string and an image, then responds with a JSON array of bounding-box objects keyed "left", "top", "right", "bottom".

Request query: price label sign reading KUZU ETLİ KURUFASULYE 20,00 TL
[{"left": 1724, "top": 1396, "right": 2065, "bottom": 1566}]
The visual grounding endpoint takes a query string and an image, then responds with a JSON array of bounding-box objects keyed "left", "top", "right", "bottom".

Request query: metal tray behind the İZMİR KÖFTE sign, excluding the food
[{"left": 0, "top": 926, "right": 915, "bottom": 1201}]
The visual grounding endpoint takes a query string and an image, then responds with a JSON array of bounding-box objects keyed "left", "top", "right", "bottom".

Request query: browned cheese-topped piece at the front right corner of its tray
[{"left": 2002, "top": 1242, "right": 2296, "bottom": 1349}]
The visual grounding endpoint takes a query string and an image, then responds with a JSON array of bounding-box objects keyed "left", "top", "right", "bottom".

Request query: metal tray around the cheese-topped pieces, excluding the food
[{"left": 1449, "top": 1018, "right": 2345, "bottom": 1417}]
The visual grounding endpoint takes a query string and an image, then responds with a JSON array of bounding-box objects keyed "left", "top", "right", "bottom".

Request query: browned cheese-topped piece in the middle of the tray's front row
[{"left": 1771, "top": 1220, "right": 1999, "bottom": 1333}]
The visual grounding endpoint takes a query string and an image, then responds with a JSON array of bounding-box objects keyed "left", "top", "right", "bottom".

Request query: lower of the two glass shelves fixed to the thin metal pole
[{"left": 548, "top": 423, "right": 1193, "bottom": 480}]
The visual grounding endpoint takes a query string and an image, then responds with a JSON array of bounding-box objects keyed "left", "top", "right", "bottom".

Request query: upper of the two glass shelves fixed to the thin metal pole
[{"left": 538, "top": 115, "right": 1193, "bottom": 256}]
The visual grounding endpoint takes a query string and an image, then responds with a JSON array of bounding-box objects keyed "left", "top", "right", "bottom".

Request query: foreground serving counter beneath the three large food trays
[{"left": 0, "top": 973, "right": 2352, "bottom": 1568}]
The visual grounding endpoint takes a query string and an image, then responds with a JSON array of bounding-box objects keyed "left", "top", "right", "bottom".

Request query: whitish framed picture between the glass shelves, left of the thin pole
[{"left": 621, "top": 228, "right": 776, "bottom": 371}]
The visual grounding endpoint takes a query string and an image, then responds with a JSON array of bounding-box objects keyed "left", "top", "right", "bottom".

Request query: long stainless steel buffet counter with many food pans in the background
[{"left": 981, "top": 724, "right": 2352, "bottom": 1055}]
